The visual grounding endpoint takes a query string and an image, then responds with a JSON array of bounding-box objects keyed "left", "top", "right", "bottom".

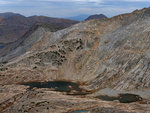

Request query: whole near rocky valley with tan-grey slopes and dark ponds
[{"left": 0, "top": 8, "right": 150, "bottom": 113}]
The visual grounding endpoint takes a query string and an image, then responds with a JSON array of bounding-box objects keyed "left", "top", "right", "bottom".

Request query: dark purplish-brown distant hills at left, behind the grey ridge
[{"left": 0, "top": 13, "right": 78, "bottom": 46}]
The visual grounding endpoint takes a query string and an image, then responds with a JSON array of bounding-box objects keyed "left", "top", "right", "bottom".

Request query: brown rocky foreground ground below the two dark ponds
[{"left": 0, "top": 85, "right": 150, "bottom": 113}]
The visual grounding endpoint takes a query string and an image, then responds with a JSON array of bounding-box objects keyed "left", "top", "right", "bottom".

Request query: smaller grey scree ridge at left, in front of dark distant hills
[{"left": 0, "top": 23, "right": 66, "bottom": 59}]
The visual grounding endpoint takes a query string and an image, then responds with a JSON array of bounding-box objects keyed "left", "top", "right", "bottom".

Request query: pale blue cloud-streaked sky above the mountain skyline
[{"left": 0, "top": 0, "right": 150, "bottom": 17}]
